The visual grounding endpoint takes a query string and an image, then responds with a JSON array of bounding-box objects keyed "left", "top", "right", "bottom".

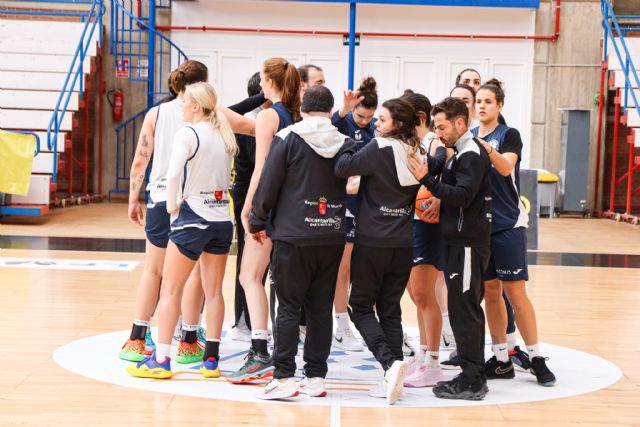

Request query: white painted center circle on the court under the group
[{"left": 53, "top": 328, "right": 622, "bottom": 407}]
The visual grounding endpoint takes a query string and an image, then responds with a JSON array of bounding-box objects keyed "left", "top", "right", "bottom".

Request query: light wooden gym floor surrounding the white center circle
[{"left": 0, "top": 204, "right": 640, "bottom": 426}]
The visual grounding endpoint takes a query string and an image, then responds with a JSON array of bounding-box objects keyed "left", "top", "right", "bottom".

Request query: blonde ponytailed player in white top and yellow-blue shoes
[{"left": 127, "top": 83, "right": 238, "bottom": 378}]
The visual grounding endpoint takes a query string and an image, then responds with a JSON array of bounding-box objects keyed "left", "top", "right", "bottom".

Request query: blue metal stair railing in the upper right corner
[{"left": 600, "top": 0, "right": 640, "bottom": 113}]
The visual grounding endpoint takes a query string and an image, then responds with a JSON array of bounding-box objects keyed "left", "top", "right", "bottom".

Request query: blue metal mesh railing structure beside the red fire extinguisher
[{"left": 109, "top": 0, "right": 187, "bottom": 196}]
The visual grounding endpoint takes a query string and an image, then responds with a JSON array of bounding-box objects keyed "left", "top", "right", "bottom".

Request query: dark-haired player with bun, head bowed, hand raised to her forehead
[{"left": 331, "top": 77, "right": 378, "bottom": 351}]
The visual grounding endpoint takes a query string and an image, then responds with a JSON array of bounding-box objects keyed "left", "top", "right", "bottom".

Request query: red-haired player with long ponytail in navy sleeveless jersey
[{"left": 227, "top": 58, "right": 301, "bottom": 383}]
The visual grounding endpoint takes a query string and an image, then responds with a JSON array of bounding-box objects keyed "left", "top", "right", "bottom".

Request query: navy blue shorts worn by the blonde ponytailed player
[{"left": 169, "top": 202, "right": 233, "bottom": 261}]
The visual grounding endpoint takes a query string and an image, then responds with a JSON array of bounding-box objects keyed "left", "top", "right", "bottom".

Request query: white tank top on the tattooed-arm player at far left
[{"left": 147, "top": 98, "right": 184, "bottom": 207}]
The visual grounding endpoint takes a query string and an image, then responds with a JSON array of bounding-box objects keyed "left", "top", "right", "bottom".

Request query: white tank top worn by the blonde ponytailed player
[{"left": 171, "top": 122, "right": 233, "bottom": 222}]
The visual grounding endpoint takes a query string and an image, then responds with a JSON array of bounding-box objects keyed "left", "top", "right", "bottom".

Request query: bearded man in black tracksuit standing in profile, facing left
[{"left": 409, "top": 98, "right": 491, "bottom": 400}]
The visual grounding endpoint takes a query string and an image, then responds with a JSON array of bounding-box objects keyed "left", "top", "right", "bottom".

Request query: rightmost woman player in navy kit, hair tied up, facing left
[{"left": 472, "top": 79, "right": 555, "bottom": 386}]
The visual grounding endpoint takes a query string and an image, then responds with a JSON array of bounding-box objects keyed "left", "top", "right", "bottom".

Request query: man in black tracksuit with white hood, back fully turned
[{"left": 249, "top": 86, "right": 347, "bottom": 399}]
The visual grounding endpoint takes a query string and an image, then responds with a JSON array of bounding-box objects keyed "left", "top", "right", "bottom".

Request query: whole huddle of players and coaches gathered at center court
[{"left": 119, "top": 58, "right": 555, "bottom": 404}]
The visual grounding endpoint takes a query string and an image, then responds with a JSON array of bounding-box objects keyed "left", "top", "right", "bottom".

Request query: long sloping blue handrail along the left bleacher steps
[{"left": 47, "top": 0, "right": 105, "bottom": 184}]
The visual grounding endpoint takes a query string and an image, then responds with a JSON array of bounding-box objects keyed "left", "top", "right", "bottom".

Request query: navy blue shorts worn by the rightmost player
[{"left": 483, "top": 227, "right": 529, "bottom": 282}]
